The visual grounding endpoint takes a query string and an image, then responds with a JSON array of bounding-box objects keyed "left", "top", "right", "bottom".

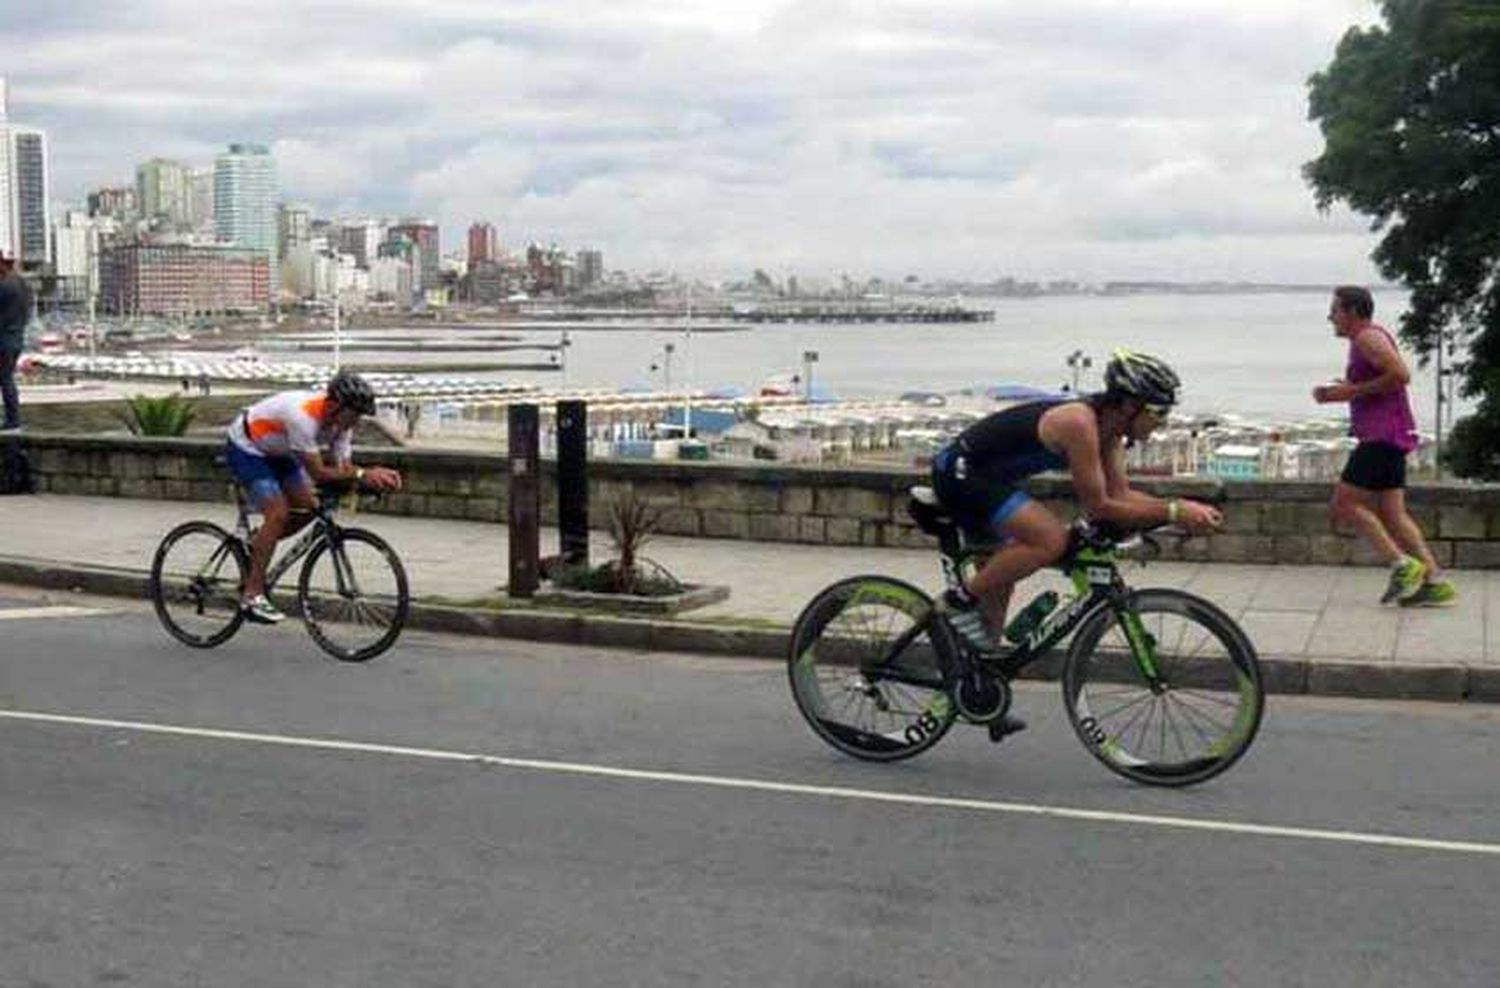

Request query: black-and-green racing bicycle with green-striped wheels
[{"left": 788, "top": 487, "right": 1266, "bottom": 786}]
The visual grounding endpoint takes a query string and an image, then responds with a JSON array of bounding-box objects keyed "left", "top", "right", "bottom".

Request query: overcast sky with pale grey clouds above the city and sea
[{"left": 0, "top": 0, "right": 1377, "bottom": 282}]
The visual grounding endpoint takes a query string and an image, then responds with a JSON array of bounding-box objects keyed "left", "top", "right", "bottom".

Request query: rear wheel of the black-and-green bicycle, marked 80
[{"left": 788, "top": 576, "right": 957, "bottom": 762}]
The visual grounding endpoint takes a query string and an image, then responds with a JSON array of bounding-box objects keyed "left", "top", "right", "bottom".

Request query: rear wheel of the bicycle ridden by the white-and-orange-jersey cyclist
[{"left": 147, "top": 522, "right": 251, "bottom": 648}]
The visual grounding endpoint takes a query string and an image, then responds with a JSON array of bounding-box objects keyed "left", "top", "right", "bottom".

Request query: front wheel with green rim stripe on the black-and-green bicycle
[{"left": 1062, "top": 589, "right": 1266, "bottom": 786}]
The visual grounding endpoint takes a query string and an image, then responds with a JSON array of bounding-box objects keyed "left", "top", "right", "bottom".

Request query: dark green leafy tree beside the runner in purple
[{"left": 1304, "top": 0, "right": 1500, "bottom": 480}]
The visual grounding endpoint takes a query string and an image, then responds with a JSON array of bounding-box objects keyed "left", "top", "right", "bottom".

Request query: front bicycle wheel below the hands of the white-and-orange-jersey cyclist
[{"left": 297, "top": 528, "right": 411, "bottom": 663}]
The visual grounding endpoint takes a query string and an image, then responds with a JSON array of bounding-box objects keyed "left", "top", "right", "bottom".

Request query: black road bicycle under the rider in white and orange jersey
[{"left": 150, "top": 486, "right": 411, "bottom": 663}]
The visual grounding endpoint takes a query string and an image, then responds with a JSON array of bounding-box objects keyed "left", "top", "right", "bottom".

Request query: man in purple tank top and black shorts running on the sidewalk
[{"left": 1313, "top": 285, "right": 1458, "bottom": 607}]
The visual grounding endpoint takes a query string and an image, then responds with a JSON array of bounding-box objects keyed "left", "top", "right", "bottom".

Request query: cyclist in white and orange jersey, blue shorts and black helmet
[{"left": 227, "top": 370, "right": 401, "bottom": 624}]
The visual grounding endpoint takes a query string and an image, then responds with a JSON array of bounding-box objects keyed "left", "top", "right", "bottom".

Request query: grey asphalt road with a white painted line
[{"left": 0, "top": 588, "right": 1500, "bottom": 988}]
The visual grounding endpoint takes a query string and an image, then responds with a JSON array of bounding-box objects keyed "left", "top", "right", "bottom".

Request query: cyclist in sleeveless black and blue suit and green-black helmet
[{"left": 933, "top": 349, "right": 1223, "bottom": 730}]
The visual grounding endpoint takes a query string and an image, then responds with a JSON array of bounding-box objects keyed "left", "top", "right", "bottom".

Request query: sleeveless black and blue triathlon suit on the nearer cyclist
[{"left": 933, "top": 397, "right": 1086, "bottom": 538}]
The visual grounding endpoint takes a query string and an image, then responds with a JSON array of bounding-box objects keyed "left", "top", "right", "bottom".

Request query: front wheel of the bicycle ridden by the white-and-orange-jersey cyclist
[{"left": 297, "top": 528, "right": 411, "bottom": 663}]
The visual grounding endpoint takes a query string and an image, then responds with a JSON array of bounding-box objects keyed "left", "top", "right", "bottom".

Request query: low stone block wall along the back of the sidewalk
[{"left": 11, "top": 433, "right": 1500, "bottom": 567}]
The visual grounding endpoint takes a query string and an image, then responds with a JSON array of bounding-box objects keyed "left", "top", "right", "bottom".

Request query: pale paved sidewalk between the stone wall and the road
[{"left": 0, "top": 495, "right": 1500, "bottom": 692}]
